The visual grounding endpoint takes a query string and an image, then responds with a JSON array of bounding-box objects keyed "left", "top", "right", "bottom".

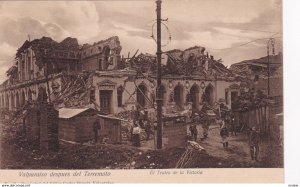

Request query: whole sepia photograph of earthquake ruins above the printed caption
[{"left": 0, "top": 0, "right": 284, "bottom": 179}]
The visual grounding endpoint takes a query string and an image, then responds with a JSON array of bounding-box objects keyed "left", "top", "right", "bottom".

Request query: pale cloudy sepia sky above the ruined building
[{"left": 0, "top": 0, "right": 282, "bottom": 82}]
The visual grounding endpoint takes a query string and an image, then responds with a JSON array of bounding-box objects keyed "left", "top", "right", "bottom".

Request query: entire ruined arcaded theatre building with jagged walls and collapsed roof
[{"left": 0, "top": 36, "right": 240, "bottom": 114}]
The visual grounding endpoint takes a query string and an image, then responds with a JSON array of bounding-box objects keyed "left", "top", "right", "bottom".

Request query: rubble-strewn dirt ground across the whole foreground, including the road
[{"left": 0, "top": 120, "right": 283, "bottom": 169}]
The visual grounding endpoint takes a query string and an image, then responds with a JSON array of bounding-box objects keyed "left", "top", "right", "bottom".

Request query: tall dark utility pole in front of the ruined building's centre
[{"left": 156, "top": 0, "right": 162, "bottom": 149}]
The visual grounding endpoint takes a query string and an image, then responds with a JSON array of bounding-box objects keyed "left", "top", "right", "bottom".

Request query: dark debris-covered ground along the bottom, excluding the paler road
[{"left": 0, "top": 118, "right": 266, "bottom": 169}]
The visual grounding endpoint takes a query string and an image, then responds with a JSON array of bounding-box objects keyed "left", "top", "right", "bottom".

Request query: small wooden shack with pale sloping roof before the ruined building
[{"left": 59, "top": 108, "right": 121, "bottom": 143}]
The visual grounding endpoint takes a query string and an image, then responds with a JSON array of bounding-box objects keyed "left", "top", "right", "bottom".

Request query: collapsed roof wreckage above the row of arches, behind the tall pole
[{"left": 123, "top": 46, "right": 236, "bottom": 80}]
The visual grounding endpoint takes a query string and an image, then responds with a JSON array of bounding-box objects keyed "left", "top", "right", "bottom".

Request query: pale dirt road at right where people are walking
[{"left": 193, "top": 125, "right": 283, "bottom": 167}]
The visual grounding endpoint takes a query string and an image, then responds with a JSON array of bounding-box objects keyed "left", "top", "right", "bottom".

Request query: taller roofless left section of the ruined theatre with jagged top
[{"left": 0, "top": 37, "right": 121, "bottom": 110}]
